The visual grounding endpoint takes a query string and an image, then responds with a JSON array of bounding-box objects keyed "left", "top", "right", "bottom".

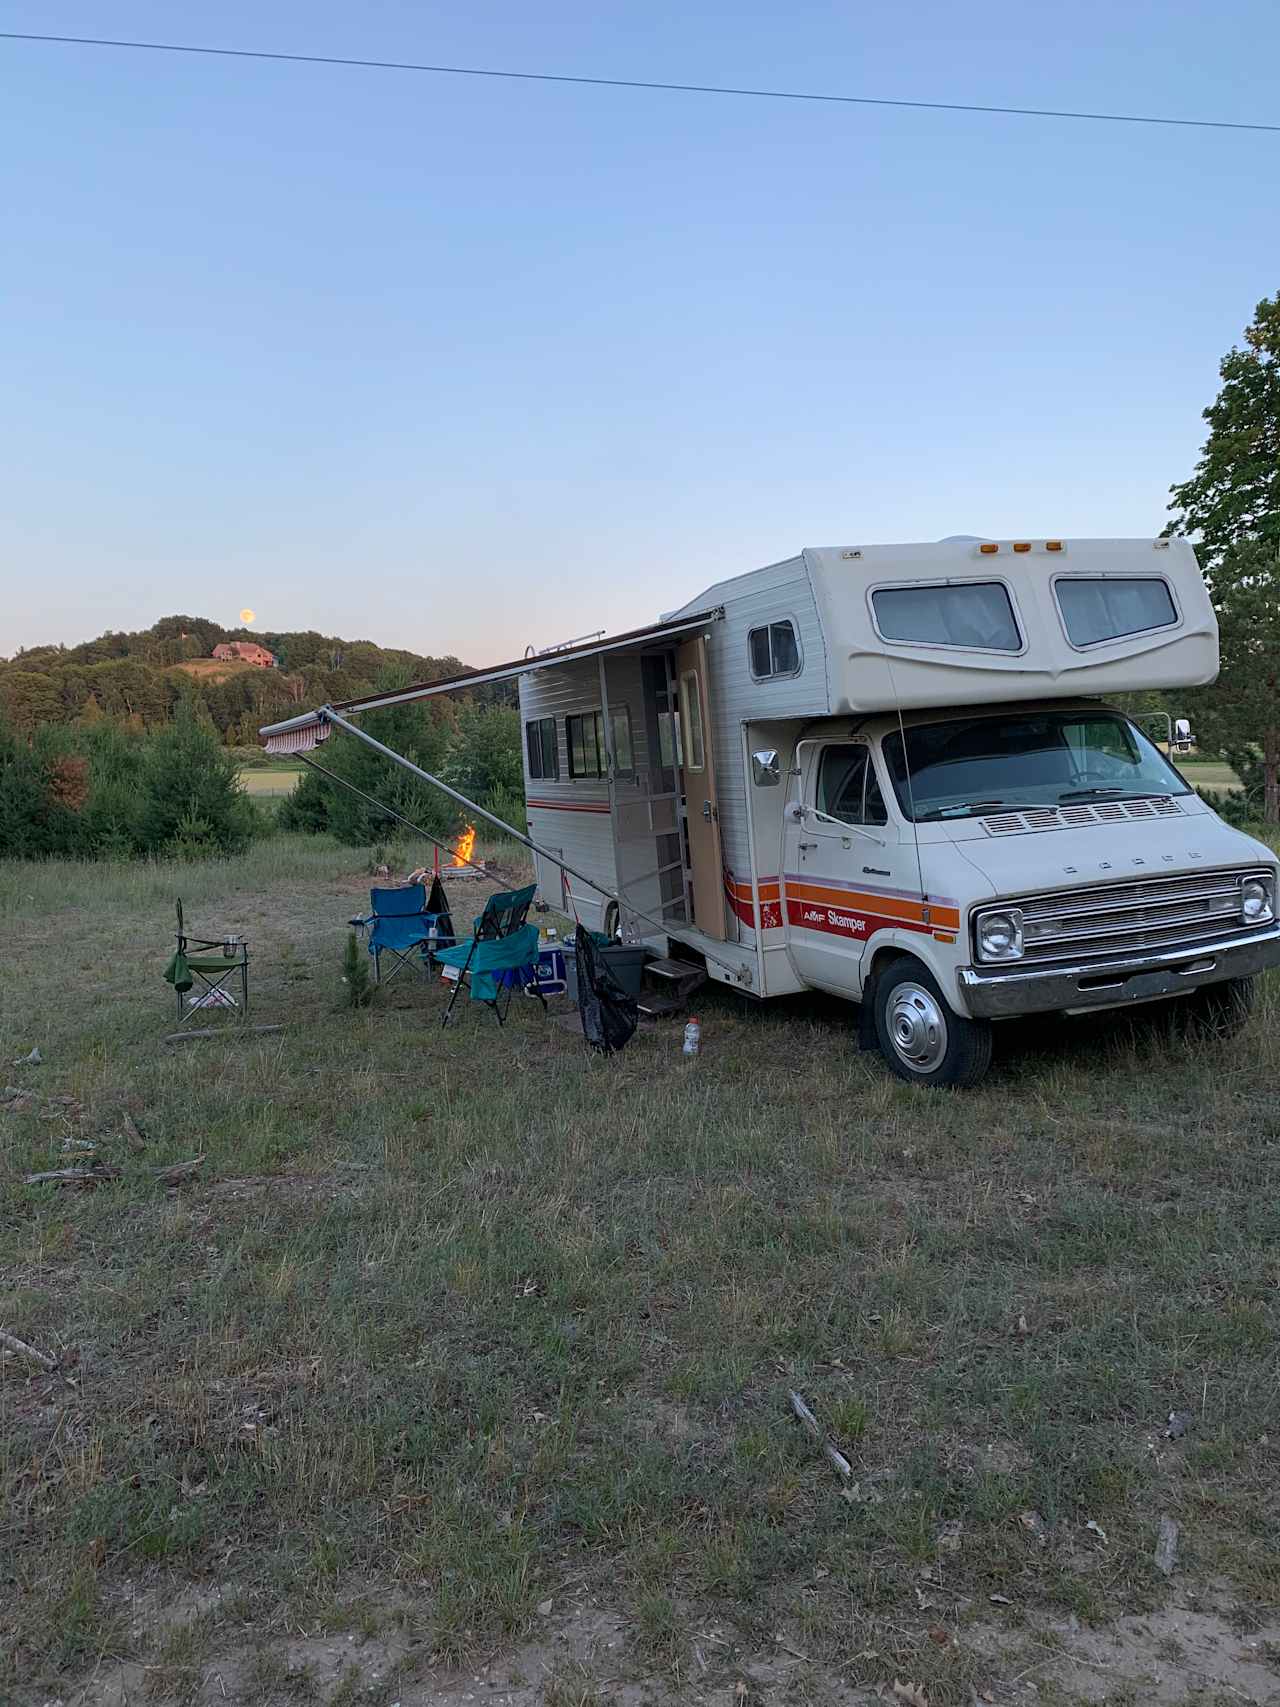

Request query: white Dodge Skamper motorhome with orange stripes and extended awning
[{"left": 265, "top": 539, "right": 1280, "bottom": 1086}]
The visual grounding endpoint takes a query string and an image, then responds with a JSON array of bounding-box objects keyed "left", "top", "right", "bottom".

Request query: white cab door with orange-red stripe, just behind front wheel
[{"left": 783, "top": 741, "right": 898, "bottom": 995}]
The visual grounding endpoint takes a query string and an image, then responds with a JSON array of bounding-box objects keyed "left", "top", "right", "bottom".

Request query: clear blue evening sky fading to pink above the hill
[{"left": 0, "top": 0, "right": 1280, "bottom": 664}]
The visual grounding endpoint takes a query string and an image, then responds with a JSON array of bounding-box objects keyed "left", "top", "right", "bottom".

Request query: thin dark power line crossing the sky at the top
[{"left": 0, "top": 29, "right": 1280, "bottom": 135}]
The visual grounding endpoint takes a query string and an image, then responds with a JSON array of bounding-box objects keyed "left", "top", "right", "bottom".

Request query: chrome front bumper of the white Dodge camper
[{"left": 956, "top": 922, "right": 1280, "bottom": 1019}]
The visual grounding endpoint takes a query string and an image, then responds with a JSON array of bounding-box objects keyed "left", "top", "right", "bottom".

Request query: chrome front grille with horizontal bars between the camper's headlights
[{"left": 1014, "top": 869, "right": 1270, "bottom": 964}]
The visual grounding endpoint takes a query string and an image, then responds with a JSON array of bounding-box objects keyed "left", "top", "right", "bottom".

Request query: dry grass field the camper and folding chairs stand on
[{"left": 0, "top": 836, "right": 1280, "bottom": 1707}]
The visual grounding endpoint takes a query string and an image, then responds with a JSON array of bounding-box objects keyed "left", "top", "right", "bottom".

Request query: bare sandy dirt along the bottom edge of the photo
[{"left": 46, "top": 1589, "right": 1280, "bottom": 1707}]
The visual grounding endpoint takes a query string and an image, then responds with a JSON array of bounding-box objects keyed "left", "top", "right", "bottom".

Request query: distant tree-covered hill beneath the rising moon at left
[{"left": 0, "top": 616, "right": 507, "bottom": 746}]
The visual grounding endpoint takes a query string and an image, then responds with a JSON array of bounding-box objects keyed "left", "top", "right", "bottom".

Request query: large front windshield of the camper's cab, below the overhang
[{"left": 882, "top": 710, "right": 1191, "bottom": 823}]
